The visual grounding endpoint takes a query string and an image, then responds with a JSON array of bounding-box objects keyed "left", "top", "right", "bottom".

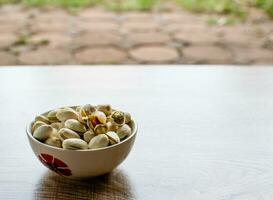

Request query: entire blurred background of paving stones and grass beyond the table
[{"left": 0, "top": 0, "right": 273, "bottom": 65}]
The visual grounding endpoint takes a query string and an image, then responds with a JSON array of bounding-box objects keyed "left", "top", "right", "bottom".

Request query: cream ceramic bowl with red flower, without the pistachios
[{"left": 26, "top": 108, "right": 137, "bottom": 178}]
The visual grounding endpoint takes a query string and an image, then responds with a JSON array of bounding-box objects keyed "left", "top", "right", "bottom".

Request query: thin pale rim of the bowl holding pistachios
[{"left": 26, "top": 106, "right": 138, "bottom": 152}]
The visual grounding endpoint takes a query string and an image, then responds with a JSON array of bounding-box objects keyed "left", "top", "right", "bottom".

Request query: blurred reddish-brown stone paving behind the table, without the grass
[{"left": 0, "top": 5, "right": 273, "bottom": 65}]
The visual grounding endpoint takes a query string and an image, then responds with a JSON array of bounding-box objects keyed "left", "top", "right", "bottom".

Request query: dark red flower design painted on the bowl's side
[{"left": 39, "top": 153, "right": 72, "bottom": 176}]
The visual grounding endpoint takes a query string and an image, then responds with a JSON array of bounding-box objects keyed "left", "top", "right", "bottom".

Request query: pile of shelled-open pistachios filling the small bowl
[{"left": 31, "top": 104, "right": 132, "bottom": 150}]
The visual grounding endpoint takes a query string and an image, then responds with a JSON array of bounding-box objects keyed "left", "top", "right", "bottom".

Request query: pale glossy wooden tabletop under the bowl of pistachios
[{"left": 0, "top": 66, "right": 273, "bottom": 200}]
